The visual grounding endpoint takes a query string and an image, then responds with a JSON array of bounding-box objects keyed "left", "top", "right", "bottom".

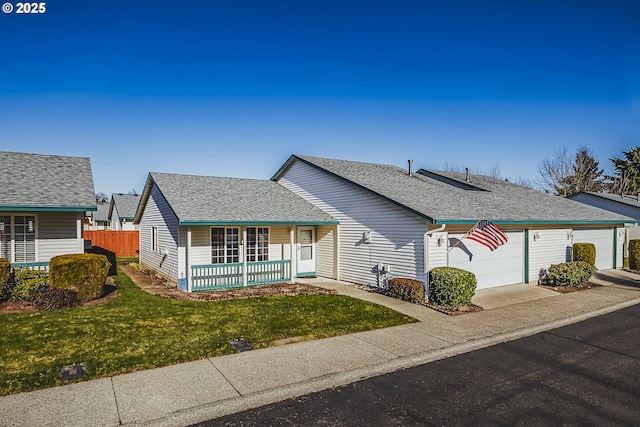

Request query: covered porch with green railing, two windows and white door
[{"left": 178, "top": 224, "right": 337, "bottom": 292}]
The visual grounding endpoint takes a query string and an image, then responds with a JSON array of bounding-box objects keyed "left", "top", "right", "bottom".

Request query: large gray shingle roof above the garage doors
[{"left": 282, "top": 155, "right": 634, "bottom": 224}]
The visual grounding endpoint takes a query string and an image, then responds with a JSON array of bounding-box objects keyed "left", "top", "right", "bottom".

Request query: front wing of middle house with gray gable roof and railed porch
[{"left": 133, "top": 172, "right": 338, "bottom": 291}]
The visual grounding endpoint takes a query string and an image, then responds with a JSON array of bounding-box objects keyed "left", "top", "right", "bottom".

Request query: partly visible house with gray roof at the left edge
[{"left": 0, "top": 152, "right": 96, "bottom": 265}]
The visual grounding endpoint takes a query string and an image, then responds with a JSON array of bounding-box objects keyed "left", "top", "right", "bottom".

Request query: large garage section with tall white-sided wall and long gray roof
[{"left": 272, "top": 155, "right": 632, "bottom": 288}]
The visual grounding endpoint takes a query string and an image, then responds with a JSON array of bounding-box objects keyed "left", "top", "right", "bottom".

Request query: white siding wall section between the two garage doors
[{"left": 529, "top": 229, "right": 571, "bottom": 282}]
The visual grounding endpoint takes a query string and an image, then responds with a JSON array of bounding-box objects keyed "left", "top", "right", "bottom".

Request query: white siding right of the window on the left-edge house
[{"left": 36, "top": 212, "right": 84, "bottom": 262}]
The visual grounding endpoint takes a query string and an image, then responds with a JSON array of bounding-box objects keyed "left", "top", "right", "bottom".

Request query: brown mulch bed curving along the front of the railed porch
[{"left": 120, "top": 263, "right": 338, "bottom": 301}]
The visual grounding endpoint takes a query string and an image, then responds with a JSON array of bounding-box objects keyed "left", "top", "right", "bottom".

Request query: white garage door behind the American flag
[{"left": 449, "top": 231, "right": 524, "bottom": 289}]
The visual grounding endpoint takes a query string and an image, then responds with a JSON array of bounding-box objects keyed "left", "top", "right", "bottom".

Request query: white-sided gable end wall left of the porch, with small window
[{"left": 140, "top": 184, "right": 179, "bottom": 280}]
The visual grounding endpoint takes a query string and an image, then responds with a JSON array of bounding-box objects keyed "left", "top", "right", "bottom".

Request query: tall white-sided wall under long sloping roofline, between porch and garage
[{"left": 278, "top": 161, "right": 427, "bottom": 285}]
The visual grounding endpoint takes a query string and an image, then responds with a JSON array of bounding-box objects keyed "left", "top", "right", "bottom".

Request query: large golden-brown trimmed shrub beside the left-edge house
[{"left": 49, "top": 254, "right": 111, "bottom": 302}]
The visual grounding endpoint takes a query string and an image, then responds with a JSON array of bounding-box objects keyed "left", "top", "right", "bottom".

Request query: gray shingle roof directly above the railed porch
[{"left": 137, "top": 172, "right": 338, "bottom": 224}]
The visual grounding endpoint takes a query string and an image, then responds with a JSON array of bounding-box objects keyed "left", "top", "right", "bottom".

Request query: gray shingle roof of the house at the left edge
[{"left": 0, "top": 151, "right": 96, "bottom": 211}]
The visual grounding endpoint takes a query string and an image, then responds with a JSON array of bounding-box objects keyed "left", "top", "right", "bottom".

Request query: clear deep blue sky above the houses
[{"left": 0, "top": 0, "right": 640, "bottom": 194}]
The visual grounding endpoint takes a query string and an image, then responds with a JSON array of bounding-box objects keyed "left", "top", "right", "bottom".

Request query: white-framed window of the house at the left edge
[{"left": 0, "top": 215, "right": 36, "bottom": 262}]
